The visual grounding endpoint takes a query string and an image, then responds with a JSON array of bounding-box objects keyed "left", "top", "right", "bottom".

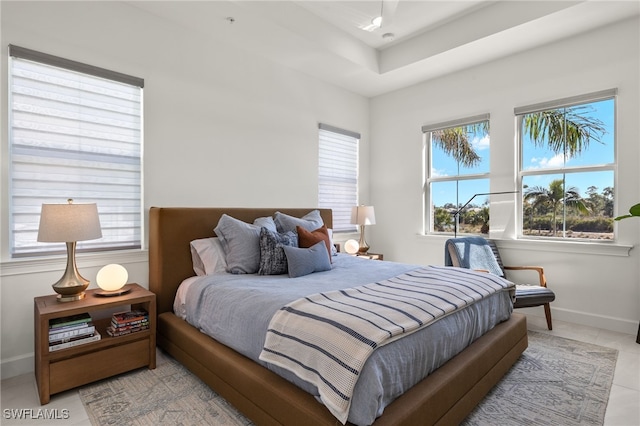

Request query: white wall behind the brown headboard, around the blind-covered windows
[{"left": 0, "top": 1, "right": 369, "bottom": 378}]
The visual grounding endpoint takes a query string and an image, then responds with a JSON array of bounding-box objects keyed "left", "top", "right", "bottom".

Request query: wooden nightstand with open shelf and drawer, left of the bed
[{"left": 33, "top": 284, "right": 156, "bottom": 404}]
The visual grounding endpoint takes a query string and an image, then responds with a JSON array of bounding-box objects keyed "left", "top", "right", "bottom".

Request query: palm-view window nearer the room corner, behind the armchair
[{"left": 422, "top": 115, "right": 489, "bottom": 233}]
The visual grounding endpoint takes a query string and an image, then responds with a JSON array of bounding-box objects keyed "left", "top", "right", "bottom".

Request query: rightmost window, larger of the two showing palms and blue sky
[{"left": 515, "top": 90, "right": 616, "bottom": 240}]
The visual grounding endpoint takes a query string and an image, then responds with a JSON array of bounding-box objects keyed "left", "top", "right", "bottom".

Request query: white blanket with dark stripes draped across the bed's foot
[{"left": 260, "top": 266, "right": 514, "bottom": 424}]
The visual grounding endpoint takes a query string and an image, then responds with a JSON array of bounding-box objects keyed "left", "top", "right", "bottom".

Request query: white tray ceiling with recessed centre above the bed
[{"left": 128, "top": 0, "right": 640, "bottom": 97}]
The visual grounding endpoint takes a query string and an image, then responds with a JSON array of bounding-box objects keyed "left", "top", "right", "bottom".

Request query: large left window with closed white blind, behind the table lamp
[{"left": 9, "top": 46, "right": 144, "bottom": 257}]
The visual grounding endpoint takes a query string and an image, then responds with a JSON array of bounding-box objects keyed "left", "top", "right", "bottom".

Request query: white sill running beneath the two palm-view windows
[{"left": 418, "top": 234, "right": 634, "bottom": 257}]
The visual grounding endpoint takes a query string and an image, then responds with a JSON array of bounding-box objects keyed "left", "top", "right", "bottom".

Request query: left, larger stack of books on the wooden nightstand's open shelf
[{"left": 49, "top": 313, "right": 100, "bottom": 352}]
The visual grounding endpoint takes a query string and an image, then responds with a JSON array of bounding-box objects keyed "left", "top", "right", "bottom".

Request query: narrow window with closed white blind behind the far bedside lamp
[{"left": 318, "top": 124, "right": 360, "bottom": 232}]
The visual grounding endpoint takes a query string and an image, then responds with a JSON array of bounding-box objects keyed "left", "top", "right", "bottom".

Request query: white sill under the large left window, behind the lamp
[{"left": 0, "top": 250, "right": 149, "bottom": 277}]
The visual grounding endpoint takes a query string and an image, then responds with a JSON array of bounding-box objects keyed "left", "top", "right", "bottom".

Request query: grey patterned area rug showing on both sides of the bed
[{"left": 79, "top": 331, "right": 618, "bottom": 426}]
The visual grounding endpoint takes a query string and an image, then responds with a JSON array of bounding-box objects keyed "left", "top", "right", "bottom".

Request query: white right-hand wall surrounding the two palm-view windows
[{"left": 368, "top": 18, "right": 640, "bottom": 335}]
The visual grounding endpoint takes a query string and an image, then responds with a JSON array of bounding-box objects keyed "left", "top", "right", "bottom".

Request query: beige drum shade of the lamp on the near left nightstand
[{"left": 38, "top": 203, "right": 102, "bottom": 243}]
